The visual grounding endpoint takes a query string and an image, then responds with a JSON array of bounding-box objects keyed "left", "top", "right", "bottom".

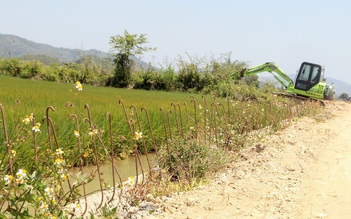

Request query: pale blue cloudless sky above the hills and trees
[{"left": 0, "top": 0, "right": 351, "bottom": 84}]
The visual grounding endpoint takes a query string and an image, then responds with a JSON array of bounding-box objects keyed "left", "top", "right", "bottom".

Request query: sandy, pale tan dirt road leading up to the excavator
[{"left": 150, "top": 102, "right": 351, "bottom": 219}]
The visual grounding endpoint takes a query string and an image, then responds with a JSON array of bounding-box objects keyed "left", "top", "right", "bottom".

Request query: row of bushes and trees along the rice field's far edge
[{"left": 0, "top": 31, "right": 259, "bottom": 96}]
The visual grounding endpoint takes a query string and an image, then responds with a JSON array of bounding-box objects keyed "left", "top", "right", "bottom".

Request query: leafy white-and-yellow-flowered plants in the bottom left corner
[{"left": 0, "top": 149, "right": 89, "bottom": 218}]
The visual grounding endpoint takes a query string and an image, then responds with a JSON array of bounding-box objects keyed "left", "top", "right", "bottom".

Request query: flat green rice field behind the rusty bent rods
[{"left": 0, "top": 76, "right": 206, "bottom": 169}]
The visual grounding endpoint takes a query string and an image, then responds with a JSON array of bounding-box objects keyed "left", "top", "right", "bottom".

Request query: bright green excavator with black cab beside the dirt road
[{"left": 240, "top": 62, "right": 336, "bottom": 100}]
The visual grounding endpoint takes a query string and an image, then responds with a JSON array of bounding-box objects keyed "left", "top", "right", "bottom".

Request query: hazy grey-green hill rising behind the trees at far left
[{"left": 0, "top": 34, "right": 109, "bottom": 62}]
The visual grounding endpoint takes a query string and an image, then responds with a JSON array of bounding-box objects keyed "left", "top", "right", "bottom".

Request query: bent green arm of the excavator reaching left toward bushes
[{"left": 240, "top": 62, "right": 294, "bottom": 89}]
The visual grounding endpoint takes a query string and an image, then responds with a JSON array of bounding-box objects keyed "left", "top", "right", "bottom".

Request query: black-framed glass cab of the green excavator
[{"left": 295, "top": 62, "right": 324, "bottom": 91}]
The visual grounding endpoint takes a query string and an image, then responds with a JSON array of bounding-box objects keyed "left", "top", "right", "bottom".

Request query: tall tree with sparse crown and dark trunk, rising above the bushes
[{"left": 109, "top": 30, "right": 155, "bottom": 87}]
